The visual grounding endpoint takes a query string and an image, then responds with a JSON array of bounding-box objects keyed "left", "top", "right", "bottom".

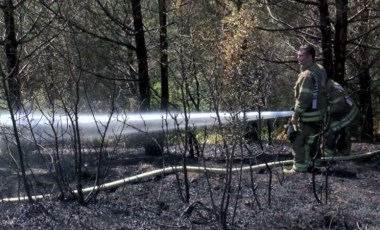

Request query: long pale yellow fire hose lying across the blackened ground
[{"left": 0, "top": 150, "right": 380, "bottom": 202}]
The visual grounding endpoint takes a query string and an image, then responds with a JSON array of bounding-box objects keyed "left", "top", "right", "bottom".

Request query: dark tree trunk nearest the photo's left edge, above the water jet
[{"left": 2, "top": 0, "right": 21, "bottom": 110}]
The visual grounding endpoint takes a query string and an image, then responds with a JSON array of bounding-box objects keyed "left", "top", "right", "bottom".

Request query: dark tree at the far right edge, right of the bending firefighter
[{"left": 347, "top": 1, "right": 380, "bottom": 140}]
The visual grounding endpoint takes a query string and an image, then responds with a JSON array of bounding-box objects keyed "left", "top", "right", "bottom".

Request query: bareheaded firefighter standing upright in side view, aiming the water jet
[{"left": 284, "top": 45, "right": 327, "bottom": 173}]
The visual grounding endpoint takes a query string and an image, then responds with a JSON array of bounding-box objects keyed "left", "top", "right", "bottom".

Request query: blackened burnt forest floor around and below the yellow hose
[{"left": 0, "top": 142, "right": 380, "bottom": 229}]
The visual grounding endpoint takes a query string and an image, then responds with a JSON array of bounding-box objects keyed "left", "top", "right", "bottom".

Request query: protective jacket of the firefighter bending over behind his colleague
[{"left": 327, "top": 79, "right": 359, "bottom": 132}]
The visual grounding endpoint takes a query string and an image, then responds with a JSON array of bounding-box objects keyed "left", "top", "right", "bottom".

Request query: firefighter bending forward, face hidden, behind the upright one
[{"left": 324, "top": 79, "right": 359, "bottom": 157}]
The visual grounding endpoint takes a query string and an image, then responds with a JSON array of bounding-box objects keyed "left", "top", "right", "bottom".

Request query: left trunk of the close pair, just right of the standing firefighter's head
[{"left": 318, "top": 0, "right": 334, "bottom": 77}]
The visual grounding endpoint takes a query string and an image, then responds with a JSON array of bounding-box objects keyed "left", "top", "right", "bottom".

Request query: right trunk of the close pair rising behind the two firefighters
[{"left": 331, "top": 0, "right": 348, "bottom": 85}]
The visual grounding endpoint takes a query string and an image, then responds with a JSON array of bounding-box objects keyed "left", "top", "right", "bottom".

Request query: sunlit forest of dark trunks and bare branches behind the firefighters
[{"left": 0, "top": 0, "right": 380, "bottom": 228}]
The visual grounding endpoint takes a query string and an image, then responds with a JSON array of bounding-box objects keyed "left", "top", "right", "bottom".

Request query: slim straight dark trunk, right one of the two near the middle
[{"left": 158, "top": 0, "right": 169, "bottom": 111}]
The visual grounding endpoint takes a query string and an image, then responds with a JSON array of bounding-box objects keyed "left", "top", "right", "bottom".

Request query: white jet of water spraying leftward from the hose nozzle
[{"left": 0, "top": 111, "right": 293, "bottom": 141}]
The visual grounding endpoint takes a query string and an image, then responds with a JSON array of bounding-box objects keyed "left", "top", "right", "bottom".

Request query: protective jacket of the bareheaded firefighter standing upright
[{"left": 294, "top": 62, "right": 327, "bottom": 122}]
